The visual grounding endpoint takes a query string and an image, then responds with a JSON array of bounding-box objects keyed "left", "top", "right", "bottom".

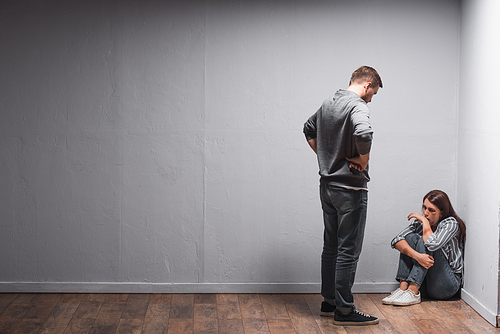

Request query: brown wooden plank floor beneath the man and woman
[{"left": 0, "top": 294, "right": 500, "bottom": 334}]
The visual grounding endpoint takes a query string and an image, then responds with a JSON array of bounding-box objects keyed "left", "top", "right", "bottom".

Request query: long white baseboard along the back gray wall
[{"left": 0, "top": 282, "right": 397, "bottom": 293}]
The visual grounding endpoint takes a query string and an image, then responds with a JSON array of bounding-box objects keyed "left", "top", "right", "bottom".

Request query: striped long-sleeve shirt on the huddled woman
[{"left": 391, "top": 217, "right": 463, "bottom": 274}]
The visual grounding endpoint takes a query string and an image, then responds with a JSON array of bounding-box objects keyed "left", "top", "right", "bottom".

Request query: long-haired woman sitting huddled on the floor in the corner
[{"left": 382, "top": 190, "right": 465, "bottom": 306}]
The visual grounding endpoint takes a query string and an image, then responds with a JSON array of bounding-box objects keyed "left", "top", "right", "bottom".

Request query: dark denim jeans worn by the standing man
[{"left": 320, "top": 184, "right": 368, "bottom": 313}]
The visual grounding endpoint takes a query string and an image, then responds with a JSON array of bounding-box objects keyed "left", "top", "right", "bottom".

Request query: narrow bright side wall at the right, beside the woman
[{"left": 458, "top": 0, "right": 500, "bottom": 324}]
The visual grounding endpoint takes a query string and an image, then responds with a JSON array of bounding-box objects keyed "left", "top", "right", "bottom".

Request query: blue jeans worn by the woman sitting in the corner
[{"left": 396, "top": 233, "right": 461, "bottom": 299}]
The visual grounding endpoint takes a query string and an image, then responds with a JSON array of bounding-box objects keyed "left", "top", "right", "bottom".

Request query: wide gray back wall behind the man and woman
[{"left": 0, "top": 0, "right": 460, "bottom": 292}]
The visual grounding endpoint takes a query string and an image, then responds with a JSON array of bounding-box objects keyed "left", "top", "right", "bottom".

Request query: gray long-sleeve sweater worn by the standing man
[{"left": 304, "top": 89, "right": 373, "bottom": 189}]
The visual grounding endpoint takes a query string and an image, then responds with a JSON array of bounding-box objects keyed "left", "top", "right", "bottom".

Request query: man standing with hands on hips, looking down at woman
[{"left": 304, "top": 66, "right": 382, "bottom": 326}]
